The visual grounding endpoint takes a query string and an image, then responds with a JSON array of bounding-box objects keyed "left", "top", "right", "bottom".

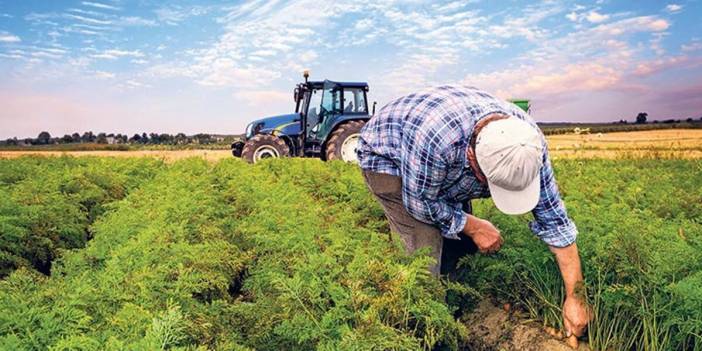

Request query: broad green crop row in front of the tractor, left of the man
[{"left": 0, "top": 160, "right": 463, "bottom": 350}]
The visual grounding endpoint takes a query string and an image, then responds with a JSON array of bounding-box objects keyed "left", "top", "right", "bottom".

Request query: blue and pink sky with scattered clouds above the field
[{"left": 0, "top": 0, "right": 702, "bottom": 139}]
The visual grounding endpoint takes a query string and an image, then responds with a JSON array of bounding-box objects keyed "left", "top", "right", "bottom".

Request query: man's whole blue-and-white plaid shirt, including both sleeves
[{"left": 357, "top": 86, "right": 577, "bottom": 247}]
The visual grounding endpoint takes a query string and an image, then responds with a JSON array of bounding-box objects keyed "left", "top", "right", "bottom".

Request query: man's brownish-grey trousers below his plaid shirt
[{"left": 363, "top": 170, "right": 477, "bottom": 275}]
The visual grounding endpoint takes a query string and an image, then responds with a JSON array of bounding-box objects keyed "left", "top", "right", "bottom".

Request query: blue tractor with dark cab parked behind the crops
[{"left": 232, "top": 71, "right": 375, "bottom": 163}]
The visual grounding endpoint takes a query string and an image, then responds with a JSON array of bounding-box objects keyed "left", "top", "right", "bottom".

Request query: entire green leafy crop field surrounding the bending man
[{"left": 0, "top": 157, "right": 702, "bottom": 350}]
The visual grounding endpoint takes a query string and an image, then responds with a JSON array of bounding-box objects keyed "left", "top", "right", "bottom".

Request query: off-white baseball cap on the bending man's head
[{"left": 475, "top": 117, "right": 543, "bottom": 215}]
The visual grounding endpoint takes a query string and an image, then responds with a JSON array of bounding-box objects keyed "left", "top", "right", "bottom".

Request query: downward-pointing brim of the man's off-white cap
[{"left": 488, "top": 175, "right": 541, "bottom": 215}]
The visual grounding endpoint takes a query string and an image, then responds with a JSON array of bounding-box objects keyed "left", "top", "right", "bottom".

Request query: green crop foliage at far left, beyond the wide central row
[{"left": 0, "top": 157, "right": 161, "bottom": 277}]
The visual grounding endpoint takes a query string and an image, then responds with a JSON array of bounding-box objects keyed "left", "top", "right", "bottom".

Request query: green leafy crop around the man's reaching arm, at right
[{"left": 463, "top": 159, "right": 702, "bottom": 350}]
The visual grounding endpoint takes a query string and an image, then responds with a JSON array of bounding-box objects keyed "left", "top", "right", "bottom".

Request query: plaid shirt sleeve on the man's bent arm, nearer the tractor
[{"left": 402, "top": 131, "right": 467, "bottom": 240}]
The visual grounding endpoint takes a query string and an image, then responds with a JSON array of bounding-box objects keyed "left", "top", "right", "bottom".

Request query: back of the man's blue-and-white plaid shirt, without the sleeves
[{"left": 358, "top": 85, "right": 536, "bottom": 179}]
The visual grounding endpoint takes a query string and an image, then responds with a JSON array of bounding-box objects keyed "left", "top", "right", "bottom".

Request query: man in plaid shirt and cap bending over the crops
[{"left": 357, "top": 86, "right": 588, "bottom": 336}]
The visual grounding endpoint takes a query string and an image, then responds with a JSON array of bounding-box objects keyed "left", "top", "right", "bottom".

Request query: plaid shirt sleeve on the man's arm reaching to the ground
[{"left": 529, "top": 148, "right": 578, "bottom": 247}]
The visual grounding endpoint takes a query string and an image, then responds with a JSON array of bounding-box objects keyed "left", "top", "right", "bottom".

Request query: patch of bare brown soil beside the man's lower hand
[{"left": 463, "top": 300, "right": 589, "bottom": 351}]
